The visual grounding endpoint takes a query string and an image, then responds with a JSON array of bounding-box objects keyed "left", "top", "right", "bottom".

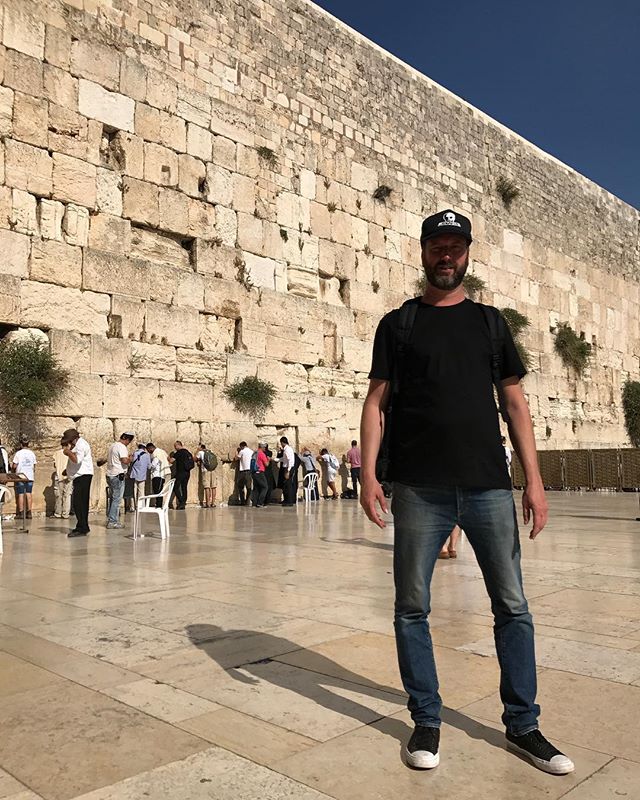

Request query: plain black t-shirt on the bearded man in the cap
[{"left": 369, "top": 300, "right": 526, "bottom": 489}]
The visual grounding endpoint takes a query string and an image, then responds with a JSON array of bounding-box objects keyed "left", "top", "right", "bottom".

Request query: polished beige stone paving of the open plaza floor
[{"left": 0, "top": 493, "right": 640, "bottom": 800}]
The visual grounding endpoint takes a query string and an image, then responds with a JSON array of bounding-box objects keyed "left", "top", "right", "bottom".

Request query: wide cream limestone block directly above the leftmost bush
[{"left": 20, "top": 280, "right": 110, "bottom": 335}]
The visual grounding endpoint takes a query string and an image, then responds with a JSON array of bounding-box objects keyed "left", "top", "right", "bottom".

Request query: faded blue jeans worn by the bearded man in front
[{"left": 392, "top": 483, "right": 540, "bottom": 735}]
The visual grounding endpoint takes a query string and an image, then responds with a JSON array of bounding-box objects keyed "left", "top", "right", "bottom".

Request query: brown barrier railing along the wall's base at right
[{"left": 511, "top": 448, "right": 640, "bottom": 491}]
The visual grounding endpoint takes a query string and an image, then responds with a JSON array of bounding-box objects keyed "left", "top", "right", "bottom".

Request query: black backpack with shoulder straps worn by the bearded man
[{"left": 376, "top": 297, "right": 510, "bottom": 483}]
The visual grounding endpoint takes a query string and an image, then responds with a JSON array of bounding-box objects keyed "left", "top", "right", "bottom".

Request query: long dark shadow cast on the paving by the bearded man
[{"left": 186, "top": 623, "right": 504, "bottom": 749}]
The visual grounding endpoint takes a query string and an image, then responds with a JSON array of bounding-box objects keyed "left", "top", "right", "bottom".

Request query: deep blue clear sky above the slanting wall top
[{"left": 315, "top": 0, "right": 640, "bottom": 208}]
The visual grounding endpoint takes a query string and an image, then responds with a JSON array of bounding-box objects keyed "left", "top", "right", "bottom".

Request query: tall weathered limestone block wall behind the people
[{"left": 0, "top": 0, "right": 640, "bottom": 512}]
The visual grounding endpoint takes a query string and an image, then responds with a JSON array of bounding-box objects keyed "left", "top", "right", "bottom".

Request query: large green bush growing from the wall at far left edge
[{"left": 0, "top": 336, "right": 68, "bottom": 413}]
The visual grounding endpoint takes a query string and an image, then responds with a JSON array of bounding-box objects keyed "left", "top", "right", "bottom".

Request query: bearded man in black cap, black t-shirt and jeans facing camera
[{"left": 361, "top": 210, "right": 574, "bottom": 774}]
